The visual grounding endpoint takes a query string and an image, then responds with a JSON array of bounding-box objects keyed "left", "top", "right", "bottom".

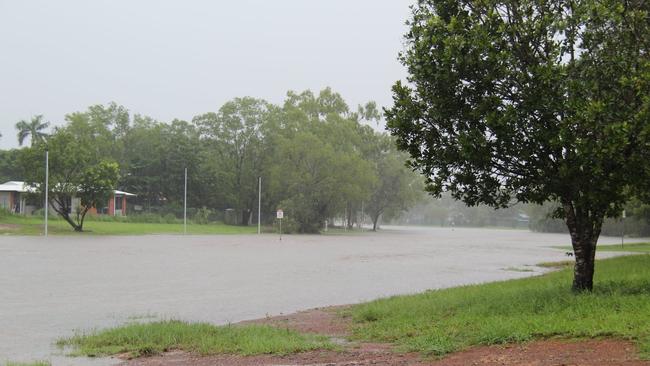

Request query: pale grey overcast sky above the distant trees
[{"left": 0, "top": 0, "right": 411, "bottom": 148}]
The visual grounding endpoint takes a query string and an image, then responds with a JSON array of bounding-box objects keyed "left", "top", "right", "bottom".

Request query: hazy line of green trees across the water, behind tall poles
[{"left": 0, "top": 88, "right": 423, "bottom": 232}]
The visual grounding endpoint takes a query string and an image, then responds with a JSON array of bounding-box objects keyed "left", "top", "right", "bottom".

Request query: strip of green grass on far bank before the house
[{"left": 0, "top": 215, "right": 257, "bottom": 235}]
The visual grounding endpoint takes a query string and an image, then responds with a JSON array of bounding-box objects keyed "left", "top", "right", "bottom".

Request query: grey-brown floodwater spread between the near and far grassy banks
[{"left": 0, "top": 227, "right": 641, "bottom": 365}]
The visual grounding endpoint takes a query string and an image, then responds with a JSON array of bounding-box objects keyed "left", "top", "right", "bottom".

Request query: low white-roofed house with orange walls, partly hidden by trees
[{"left": 0, "top": 181, "right": 136, "bottom": 216}]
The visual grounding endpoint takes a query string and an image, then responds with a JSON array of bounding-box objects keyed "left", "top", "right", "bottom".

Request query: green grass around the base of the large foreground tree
[{"left": 349, "top": 255, "right": 650, "bottom": 357}]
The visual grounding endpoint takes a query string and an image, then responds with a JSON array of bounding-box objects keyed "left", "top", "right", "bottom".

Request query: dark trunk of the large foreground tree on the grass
[{"left": 563, "top": 202, "right": 604, "bottom": 292}]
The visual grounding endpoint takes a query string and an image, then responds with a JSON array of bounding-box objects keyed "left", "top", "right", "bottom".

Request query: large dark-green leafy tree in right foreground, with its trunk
[{"left": 386, "top": 0, "right": 650, "bottom": 291}]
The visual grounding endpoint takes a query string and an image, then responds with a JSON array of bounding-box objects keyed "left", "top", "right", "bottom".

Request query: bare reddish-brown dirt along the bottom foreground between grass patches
[{"left": 125, "top": 307, "right": 650, "bottom": 366}]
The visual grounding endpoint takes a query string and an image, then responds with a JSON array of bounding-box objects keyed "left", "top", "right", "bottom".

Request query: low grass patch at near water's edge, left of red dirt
[{"left": 57, "top": 320, "right": 333, "bottom": 357}]
